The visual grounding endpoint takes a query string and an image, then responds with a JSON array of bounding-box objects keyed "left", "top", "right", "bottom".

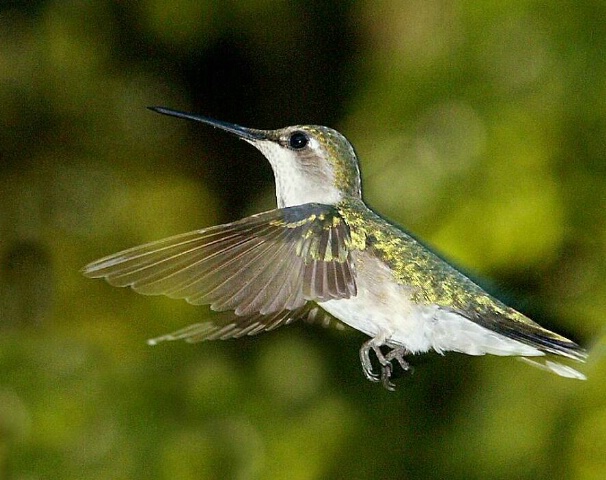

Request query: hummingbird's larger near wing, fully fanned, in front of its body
[{"left": 83, "top": 203, "right": 356, "bottom": 316}]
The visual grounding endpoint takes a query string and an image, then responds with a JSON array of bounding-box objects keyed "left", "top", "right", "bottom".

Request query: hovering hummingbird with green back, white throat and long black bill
[{"left": 83, "top": 107, "right": 587, "bottom": 390}]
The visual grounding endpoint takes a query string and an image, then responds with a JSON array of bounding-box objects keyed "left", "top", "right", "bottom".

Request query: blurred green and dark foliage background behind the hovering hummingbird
[{"left": 0, "top": 0, "right": 606, "bottom": 480}]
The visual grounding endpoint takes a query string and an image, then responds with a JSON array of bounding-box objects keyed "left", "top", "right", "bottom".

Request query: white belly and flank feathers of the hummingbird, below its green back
[{"left": 321, "top": 252, "right": 544, "bottom": 356}]
